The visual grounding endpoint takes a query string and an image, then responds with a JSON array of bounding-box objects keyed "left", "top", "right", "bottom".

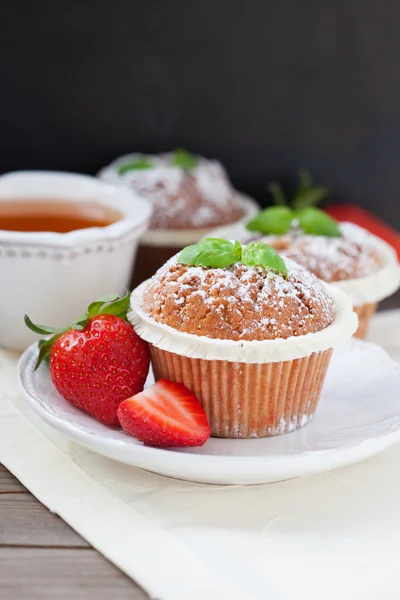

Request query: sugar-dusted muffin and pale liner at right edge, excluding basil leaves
[{"left": 210, "top": 209, "right": 400, "bottom": 338}]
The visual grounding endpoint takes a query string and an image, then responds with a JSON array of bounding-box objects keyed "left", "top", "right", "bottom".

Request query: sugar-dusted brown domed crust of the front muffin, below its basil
[{"left": 143, "top": 257, "right": 335, "bottom": 341}]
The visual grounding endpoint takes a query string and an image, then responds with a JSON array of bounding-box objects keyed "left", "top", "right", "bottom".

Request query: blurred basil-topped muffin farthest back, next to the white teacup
[{"left": 99, "top": 150, "right": 259, "bottom": 284}]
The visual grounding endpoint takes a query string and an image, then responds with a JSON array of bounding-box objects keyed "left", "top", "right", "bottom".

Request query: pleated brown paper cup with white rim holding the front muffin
[{"left": 129, "top": 282, "right": 357, "bottom": 438}]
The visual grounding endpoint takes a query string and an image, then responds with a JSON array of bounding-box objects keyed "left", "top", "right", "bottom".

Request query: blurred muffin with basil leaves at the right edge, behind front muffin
[{"left": 210, "top": 206, "right": 400, "bottom": 338}]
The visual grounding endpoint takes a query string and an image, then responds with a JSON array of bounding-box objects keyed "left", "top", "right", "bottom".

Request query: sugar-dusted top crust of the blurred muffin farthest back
[{"left": 102, "top": 153, "right": 244, "bottom": 229}]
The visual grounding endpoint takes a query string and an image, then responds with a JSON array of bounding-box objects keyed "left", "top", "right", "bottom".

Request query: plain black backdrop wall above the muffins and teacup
[{"left": 0, "top": 0, "right": 400, "bottom": 228}]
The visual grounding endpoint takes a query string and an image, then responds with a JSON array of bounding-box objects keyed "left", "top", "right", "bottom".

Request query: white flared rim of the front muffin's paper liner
[{"left": 128, "top": 281, "right": 358, "bottom": 364}]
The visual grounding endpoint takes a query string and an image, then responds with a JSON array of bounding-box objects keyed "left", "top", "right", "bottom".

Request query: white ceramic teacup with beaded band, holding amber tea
[{"left": 0, "top": 171, "right": 151, "bottom": 350}]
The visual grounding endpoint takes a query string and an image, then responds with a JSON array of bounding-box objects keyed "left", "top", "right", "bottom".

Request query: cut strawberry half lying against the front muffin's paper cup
[{"left": 118, "top": 379, "right": 210, "bottom": 448}]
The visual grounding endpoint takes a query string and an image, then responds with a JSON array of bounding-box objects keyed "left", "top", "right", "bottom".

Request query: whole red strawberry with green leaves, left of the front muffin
[{"left": 25, "top": 294, "right": 150, "bottom": 425}]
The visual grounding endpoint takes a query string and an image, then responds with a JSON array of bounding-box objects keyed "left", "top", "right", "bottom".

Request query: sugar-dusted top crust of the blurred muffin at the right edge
[{"left": 259, "top": 223, "right": 380, "bottom": 282}]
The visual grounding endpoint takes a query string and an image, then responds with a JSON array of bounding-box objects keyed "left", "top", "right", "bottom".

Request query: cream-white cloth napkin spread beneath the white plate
[{"left": 0, "top": 311, "right": 400, "bottom": 600}]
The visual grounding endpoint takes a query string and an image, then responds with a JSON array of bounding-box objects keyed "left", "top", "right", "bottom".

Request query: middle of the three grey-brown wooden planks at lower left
[{"left": 0, "top": 493, "right": 89, "bottom": 548}]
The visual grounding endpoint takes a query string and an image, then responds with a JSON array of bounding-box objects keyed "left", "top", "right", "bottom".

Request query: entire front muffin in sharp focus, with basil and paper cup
[{"left": 129, "top": 240, "right": 357, "bottom": 438}]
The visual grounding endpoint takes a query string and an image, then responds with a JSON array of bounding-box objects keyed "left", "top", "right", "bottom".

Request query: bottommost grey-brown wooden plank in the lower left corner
[{"left": 0, "top": 548, "right": 147, "bottom": 600}]
